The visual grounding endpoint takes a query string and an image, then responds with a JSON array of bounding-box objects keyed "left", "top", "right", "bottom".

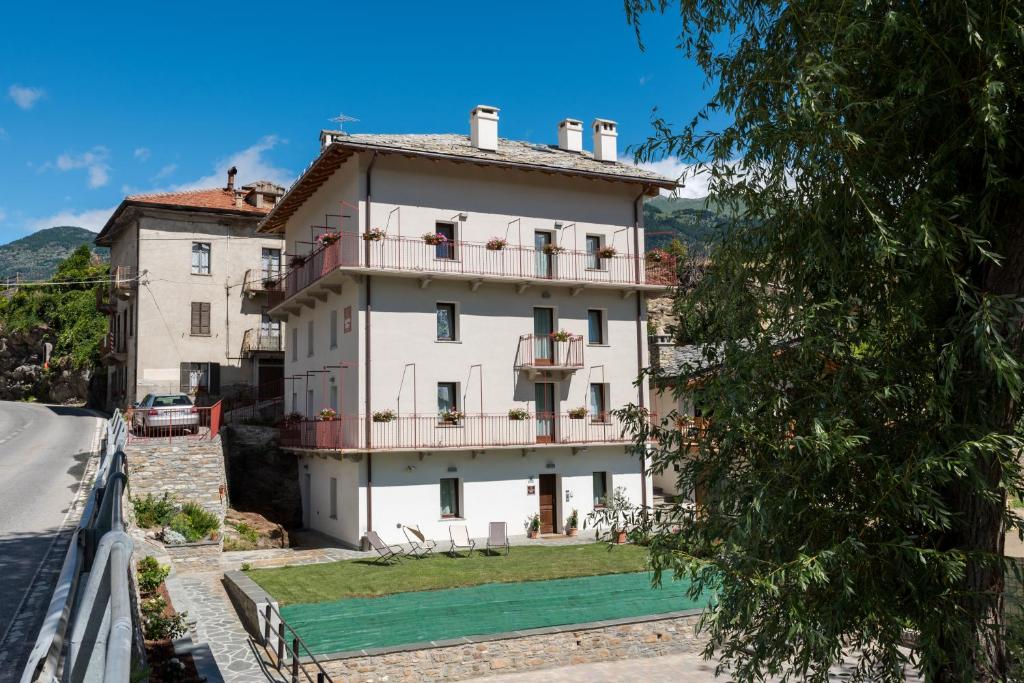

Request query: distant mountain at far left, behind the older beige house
[{"left": 0, "top": 225, "right": 110, "bottom": 283}]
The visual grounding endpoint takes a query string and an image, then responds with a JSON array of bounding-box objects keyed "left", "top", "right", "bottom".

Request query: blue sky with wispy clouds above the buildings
[{"left": 0, "top": 0, "right": 720, "bottom": 243}]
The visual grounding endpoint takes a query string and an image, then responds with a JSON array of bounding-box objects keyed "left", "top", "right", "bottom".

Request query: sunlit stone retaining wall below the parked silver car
[{"left": 125, "top": 436, "right": 226, "bottom": 519}]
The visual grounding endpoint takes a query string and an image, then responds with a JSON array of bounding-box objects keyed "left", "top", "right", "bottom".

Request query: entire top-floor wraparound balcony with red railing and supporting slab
[{"left": 266, "top": 232, "right": 665, "bottom": 307}]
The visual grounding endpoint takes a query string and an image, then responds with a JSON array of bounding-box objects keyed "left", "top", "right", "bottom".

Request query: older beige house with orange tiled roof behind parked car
[{"left": 96, "top": 168, "right": 284, "bottom": 408}]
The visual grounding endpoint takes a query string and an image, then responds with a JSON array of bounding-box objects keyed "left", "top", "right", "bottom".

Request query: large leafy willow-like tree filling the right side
[{"left": 625, "top": 0, "right": 1024, "bottom": 681}]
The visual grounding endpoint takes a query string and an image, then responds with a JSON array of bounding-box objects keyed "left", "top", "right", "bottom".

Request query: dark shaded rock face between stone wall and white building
[{"left": 220, "top": 425, "right": 302, "bottom": 528}]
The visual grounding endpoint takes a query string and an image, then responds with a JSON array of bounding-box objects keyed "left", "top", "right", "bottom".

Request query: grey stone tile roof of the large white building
[{"left": 324, "top": 131, "right": 677, "bottom": 188}]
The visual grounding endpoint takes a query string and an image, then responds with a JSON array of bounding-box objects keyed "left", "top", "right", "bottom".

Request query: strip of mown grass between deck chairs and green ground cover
[{"left": 246, "top": 543, "right": 647, "bottom": 605}]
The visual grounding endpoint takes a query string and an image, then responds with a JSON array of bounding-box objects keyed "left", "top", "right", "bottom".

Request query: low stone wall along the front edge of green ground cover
[{"left": 306, "top": 612, "right": 706, "bottom": 683}]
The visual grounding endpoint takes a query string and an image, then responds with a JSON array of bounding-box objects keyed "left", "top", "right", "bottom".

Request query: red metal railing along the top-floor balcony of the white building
[{"left": 267, "top": 232, "right": 645, "bottom": 307}]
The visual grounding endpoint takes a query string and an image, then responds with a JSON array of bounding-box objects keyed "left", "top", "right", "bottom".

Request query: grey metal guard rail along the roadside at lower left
[{"left": 20, "top": 411, "right": 134, "bottom": 683}]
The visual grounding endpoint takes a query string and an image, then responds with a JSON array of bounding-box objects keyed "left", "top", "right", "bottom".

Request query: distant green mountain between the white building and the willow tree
[{"left": 643, "top": 197, "right": 725, "bottom": 251}]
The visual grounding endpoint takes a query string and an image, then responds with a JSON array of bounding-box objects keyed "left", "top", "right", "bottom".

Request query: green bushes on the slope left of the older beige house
[{"left": 0, "top": 245, "right": 110, "bottom": 370}]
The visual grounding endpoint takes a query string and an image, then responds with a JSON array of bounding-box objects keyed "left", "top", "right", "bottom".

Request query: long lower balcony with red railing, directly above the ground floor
[{"left": 281, "top": 413, "right": 631, "bottom": 452}]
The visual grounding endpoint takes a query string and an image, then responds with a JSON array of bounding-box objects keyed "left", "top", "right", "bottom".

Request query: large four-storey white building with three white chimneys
[{"left": 260, "top": 106, "right": 674, "bottom": 545}]
